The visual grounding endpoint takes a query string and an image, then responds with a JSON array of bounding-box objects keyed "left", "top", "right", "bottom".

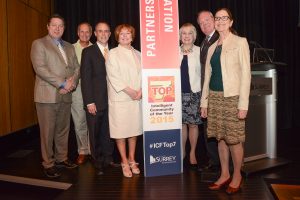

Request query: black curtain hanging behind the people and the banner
[{"left": 54, "top": 0, "right": 300, "bottom": 129}]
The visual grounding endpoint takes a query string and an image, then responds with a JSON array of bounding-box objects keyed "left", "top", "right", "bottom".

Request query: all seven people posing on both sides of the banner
[{"left": 31, "top": 8, "right": 251, "bottom": 194}]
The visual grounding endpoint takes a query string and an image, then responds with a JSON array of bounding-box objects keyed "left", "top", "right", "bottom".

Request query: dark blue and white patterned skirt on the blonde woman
[{"left": 181, "top": 92, "right": 202, "bottom": 124}]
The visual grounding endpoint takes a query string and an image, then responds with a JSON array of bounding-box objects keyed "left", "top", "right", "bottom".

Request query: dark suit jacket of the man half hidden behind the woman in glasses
[{"left": 200, "top": 31, "right": 219, "bottom": 88}]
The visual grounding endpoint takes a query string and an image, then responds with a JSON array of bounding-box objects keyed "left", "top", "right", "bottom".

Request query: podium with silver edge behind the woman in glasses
[{"left": 242, "top": 62, "right": 287, "bottom": 175}]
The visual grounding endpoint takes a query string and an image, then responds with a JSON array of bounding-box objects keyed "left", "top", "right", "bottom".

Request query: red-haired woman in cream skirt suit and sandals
[{"left": 106, "top": 24, "right": 142, "bottom": 177}]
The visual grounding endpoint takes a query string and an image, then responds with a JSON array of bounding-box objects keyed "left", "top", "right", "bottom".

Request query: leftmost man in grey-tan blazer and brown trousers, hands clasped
[{"left": 30, "top": 15, "right": 79, "bottom": 177}]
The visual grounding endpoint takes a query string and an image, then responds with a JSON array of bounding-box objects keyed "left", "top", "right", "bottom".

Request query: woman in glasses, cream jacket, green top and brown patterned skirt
[{"left": 201, "top": 8, "right": 251, "bottom": 194}]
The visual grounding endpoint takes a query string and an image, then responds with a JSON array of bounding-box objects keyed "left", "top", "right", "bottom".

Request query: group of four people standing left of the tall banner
[{"left": 31, "top": 14, "right": 142, "bottom": 177}]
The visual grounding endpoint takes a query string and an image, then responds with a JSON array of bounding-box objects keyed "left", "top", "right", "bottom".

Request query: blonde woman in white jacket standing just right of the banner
[{"left": 179, "top": 23, "right": 202, "bottom": 169}]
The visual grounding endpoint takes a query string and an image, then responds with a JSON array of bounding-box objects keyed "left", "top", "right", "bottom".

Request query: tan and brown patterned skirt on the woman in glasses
[{"left": 207, "top": 90, "right": 245, "bottom": 145}]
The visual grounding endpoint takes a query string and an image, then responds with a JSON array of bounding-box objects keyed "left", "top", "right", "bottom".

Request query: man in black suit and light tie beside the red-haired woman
[{"left": 80, "top": 22, "right": 114, "bottom": 175}]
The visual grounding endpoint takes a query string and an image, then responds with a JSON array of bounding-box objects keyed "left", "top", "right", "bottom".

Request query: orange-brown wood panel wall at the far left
[{"left": 0, "top": 0, "right": 52, "bottom": 136}]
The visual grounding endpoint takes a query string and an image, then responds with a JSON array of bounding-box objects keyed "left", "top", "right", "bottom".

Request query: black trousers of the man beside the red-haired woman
[{"left": 86, "top": 109, "right": 114, "bottom": 168}]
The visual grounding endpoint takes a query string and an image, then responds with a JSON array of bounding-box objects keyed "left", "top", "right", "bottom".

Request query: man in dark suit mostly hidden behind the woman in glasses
[{"left": 197, "top": 10, "right": 220, "bottom": 171}]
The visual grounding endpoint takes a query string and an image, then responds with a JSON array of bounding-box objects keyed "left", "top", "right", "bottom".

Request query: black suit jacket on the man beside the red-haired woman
[{"left": 80, "top": 43, "right": 108, "bottom": 111}]
